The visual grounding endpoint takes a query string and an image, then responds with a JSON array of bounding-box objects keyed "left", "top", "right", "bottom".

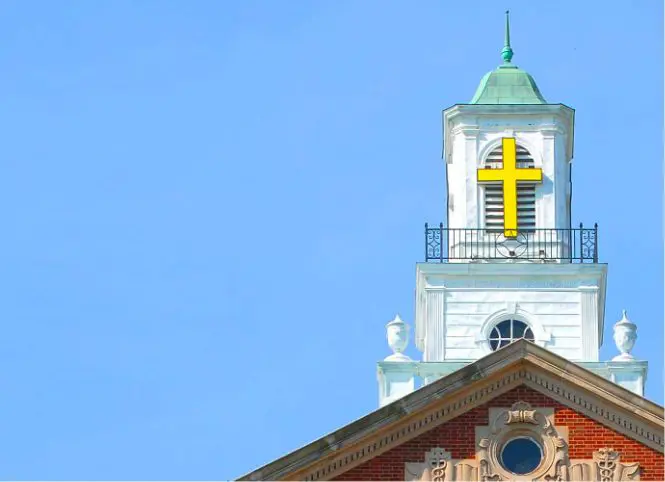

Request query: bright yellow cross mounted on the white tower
[{"left": 478, "top": 137, "right": 543, "bottom": 238}]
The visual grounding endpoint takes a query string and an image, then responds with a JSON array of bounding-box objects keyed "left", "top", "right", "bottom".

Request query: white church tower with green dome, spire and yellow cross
[{"left": 378, "top": 13, "right": 646, "bottom": 404}]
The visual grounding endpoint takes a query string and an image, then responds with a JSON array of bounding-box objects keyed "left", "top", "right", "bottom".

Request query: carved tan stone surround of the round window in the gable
[{"left": 405, "top": 402, "right": 640, "bottom": 482}]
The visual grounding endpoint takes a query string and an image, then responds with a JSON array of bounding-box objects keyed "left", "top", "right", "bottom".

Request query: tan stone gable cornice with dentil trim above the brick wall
[{"left": 239, "top": 340, "right": 665, "bottom": 480}]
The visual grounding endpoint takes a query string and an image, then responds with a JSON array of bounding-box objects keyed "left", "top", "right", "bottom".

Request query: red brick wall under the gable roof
[{"left": 334, "top": 386, "right": 665, "bottom": 481}]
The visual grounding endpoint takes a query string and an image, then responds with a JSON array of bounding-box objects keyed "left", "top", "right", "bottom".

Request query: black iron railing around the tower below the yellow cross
[{"left": 425, "top": 224, "right": 598, "bottom": 263}]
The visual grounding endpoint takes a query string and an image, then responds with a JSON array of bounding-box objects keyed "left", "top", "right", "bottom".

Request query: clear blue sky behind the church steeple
[{"left": 0, "top": 0, "right": 663, "bottom": 480}]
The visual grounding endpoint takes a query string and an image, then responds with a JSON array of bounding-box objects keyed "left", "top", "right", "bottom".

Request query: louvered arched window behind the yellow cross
[{"left": 484, "top": 145, "right": 536, "bottom": 232}]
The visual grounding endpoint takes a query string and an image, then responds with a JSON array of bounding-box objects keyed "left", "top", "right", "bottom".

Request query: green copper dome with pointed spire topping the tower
[{"left": 470, "top": 12, "right": 547, "bottom": 104}]
